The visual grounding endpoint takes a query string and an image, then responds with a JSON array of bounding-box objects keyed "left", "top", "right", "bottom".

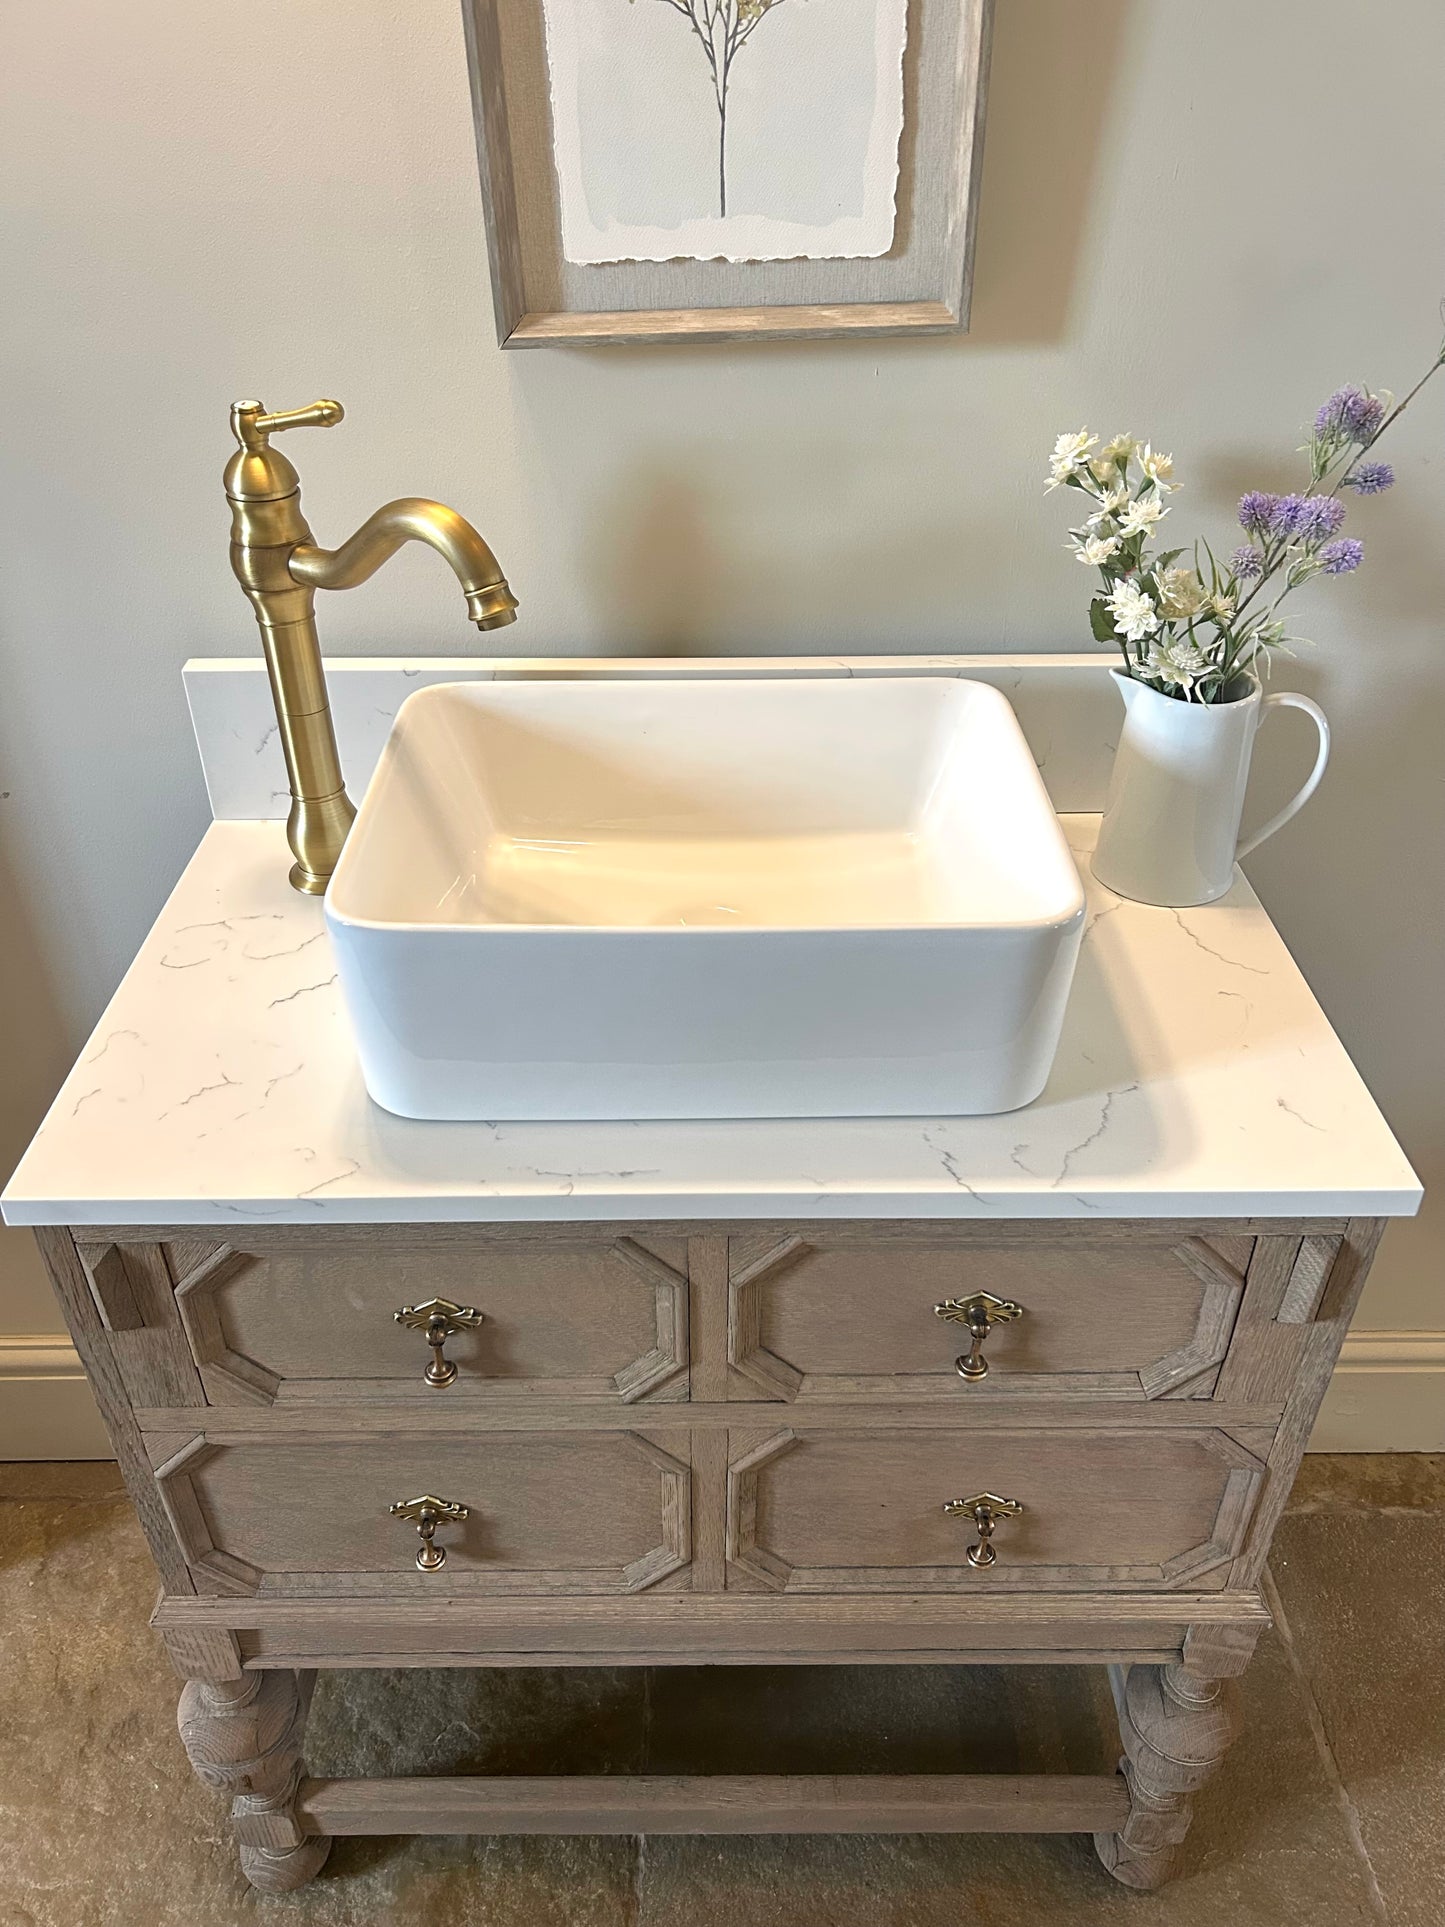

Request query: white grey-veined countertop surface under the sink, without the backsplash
[{"left": 4, "top": 817, "right": 1420, "bottom": 1226}]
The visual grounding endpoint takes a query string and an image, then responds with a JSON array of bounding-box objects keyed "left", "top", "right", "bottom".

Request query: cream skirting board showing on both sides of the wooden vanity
[{"left": 0, "top": 1332, "right": 1445, "bottom": 1461}]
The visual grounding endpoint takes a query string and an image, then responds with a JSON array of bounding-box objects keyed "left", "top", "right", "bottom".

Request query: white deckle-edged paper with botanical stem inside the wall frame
[{"left": 543, "top": 0, "right": 907, "bottom": 262}]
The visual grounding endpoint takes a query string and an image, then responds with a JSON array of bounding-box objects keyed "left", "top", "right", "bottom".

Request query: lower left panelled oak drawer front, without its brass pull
[{"left": 156, "top": 1432, "right": 692, "bottom": 1599}]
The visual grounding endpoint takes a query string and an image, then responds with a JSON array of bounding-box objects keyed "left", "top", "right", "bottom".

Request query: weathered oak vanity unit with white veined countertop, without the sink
[{"left": 6, "top": 662, "right": 1420, "bottom": 1890}]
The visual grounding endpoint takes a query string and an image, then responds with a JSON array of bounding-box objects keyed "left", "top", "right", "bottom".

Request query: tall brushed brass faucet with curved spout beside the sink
[{"left": 225, "top": 401, "right": 516, "bottom": 896}]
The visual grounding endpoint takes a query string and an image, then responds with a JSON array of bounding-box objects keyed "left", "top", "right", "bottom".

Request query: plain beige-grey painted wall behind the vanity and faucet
[{"left": 0, "top": 0, "right": 1445, "bottom": 1441}]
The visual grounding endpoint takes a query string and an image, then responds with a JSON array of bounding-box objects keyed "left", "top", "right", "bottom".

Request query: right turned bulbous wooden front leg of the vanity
[{"left": 1094, "top": 1665, "right": 1239, "bottom": 1887}]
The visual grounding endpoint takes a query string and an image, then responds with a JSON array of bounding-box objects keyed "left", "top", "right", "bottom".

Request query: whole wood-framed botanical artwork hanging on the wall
[{"left": 462, "top": 0, "right": 992, "bottom": 347}]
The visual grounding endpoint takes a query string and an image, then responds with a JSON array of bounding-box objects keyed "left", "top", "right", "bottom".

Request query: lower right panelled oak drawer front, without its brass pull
[{"left": 726, "top": 1426, "right": 1264, "bottom": 1601}]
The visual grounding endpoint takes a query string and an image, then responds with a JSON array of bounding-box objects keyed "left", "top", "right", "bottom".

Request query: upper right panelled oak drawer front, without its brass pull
[{"left": 728, "top": 1233, "right": 1254, "bottom": 1399}]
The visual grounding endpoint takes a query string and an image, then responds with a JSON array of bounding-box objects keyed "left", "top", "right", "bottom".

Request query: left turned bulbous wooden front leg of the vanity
[{"left": 175, "top": 1671, "right": 331, "bottom": 1894}]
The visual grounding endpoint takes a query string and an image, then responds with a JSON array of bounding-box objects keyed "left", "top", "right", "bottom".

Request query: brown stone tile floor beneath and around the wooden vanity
[{"left": 0, "top": 1457, "right": 1445, "bottom": 1927}]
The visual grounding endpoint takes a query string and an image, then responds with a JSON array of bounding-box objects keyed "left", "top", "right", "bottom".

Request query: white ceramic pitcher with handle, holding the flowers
[{"left": 1092, "top": 669, "right": 1329, "bottom": 910}]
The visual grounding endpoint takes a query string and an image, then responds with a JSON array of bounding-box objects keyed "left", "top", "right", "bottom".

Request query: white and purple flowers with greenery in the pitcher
[{"left": 1048, "top": 327, "right": 1445, "bottom": 703}]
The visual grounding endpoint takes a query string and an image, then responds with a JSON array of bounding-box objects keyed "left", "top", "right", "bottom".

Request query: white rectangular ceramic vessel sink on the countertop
[{"left": 326, "top": 676, "right": 1083, "bottom": 1120}]
